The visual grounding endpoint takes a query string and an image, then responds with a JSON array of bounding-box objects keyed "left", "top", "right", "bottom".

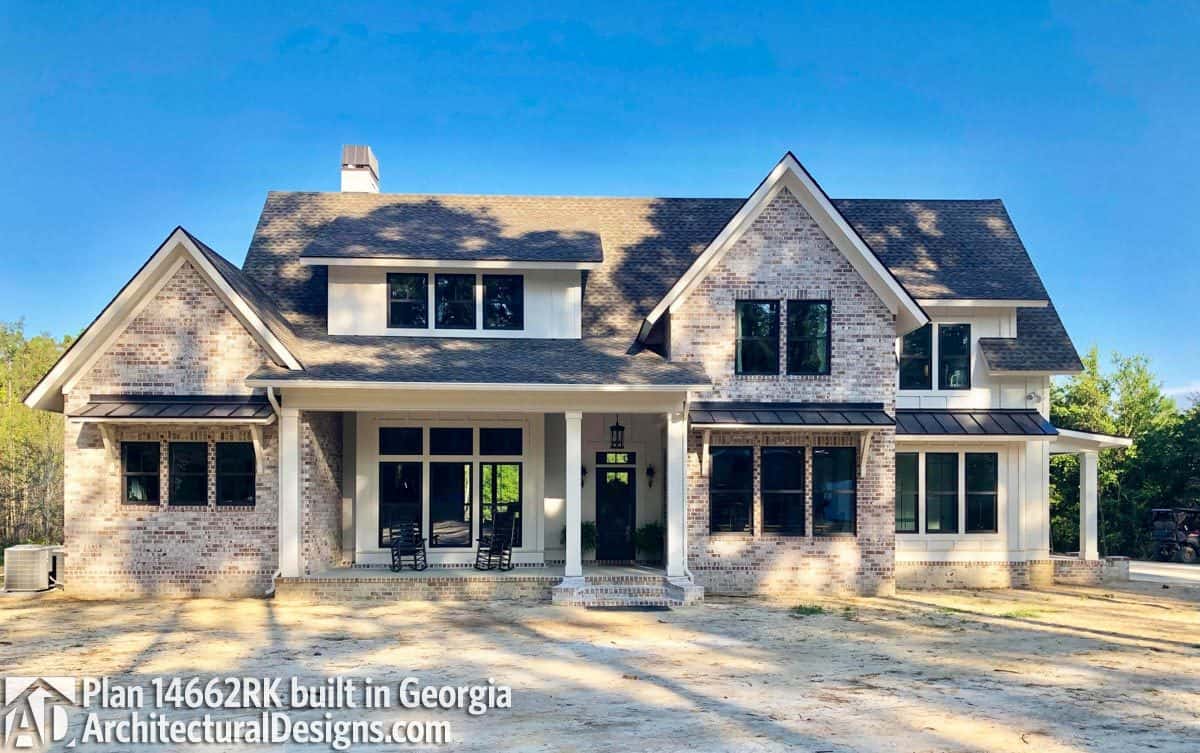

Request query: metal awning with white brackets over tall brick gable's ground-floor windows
[{"left": 688, "top": 402, "right": 895, "bottom": 476}]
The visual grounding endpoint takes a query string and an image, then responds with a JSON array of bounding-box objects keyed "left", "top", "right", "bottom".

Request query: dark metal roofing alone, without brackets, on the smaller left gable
[{"left": 71, "top": 394, "right": 274, "bottom": 422}]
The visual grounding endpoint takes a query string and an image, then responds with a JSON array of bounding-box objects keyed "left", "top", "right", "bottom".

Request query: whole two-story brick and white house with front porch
[{"left": 26, "top": 147, "right": 1123, "bottom": 603}]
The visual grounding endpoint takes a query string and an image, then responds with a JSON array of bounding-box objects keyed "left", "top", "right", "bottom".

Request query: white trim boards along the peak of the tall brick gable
[{"left": 638, "top": 152, "right": 929, "bottom": 339}]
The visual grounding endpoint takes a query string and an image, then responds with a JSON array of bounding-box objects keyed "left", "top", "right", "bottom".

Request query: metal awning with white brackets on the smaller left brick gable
[{"left": 67, "top": 394, "right": 275, "bottom": 472}]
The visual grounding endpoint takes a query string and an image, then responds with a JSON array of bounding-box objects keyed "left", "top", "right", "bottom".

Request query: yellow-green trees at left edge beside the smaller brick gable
[{"left": 0, "top": 323, "right": 71, "bottom": 546}]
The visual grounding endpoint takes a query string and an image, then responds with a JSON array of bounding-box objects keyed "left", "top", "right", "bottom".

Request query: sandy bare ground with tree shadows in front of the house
[{"left": 0, "top": 583, "right": 1200, "bottom": 753}]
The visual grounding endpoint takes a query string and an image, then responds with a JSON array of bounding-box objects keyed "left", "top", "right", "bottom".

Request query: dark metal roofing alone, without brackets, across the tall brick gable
[{"left": 688, "top": 402, "right": 895, "bottom": 428}]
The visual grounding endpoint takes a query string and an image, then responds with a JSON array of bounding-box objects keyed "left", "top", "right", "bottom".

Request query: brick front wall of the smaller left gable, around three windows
[{"left": 64, "top": 264, "right": 278, "bottom": 597}]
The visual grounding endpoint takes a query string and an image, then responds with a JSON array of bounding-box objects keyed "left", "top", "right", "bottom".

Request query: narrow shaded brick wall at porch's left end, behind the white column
[{"left": 300, "top": 411, "right": 349, "bottom": 573}]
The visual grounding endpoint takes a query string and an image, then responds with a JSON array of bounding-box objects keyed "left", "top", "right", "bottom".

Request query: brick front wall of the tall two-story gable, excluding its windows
[{"left": 671, "top": 191, "right": 895, "bottom": 598}]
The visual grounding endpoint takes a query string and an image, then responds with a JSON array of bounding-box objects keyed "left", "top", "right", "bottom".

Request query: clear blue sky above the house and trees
[{"left": 0, "top": 1, "right": 1200, "bottom": 391}]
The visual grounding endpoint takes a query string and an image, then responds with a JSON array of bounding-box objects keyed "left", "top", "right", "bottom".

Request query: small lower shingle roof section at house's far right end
[{"left": 979, "top": 303, "right": 1084, "bottom": 374}]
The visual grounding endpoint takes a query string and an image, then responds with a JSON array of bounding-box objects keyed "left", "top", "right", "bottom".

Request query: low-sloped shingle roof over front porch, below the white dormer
[{"left": 251, "top": 332, "right": 709, "bottom": 385}]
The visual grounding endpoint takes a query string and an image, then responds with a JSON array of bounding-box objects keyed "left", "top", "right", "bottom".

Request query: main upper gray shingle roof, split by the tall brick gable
[{"left": 244, "top": 192, "right": 1078, "bottom": 381}]
